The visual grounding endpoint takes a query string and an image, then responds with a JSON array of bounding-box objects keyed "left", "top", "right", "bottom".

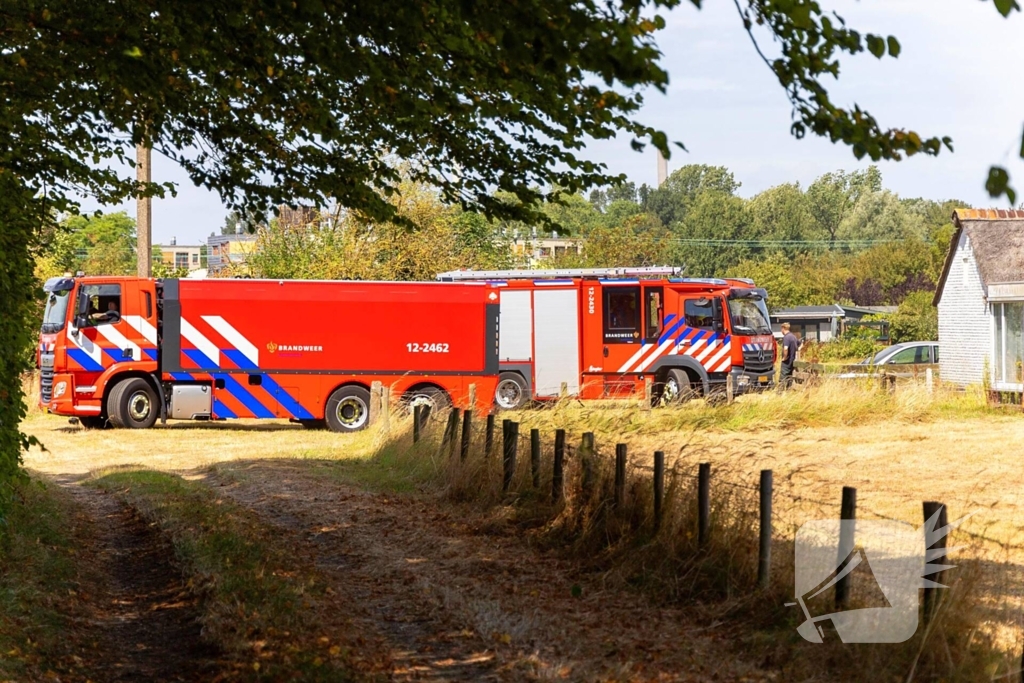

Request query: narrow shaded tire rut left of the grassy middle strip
[{"left": 60, "top": 481, "right": 217, "bottom": 683}]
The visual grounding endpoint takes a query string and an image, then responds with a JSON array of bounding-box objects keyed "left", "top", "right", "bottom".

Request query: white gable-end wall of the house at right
[{"left": 938, "top": 232, "right": 992, "bottom": 386}]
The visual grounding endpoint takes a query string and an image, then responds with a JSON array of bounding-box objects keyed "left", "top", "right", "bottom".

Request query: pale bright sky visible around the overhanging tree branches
[{"left": 85, "top": 0, "right": 1024, "bottom": 244}]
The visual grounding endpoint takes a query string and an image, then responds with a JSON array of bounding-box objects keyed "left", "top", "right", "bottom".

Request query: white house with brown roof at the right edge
[{"left": 934, "top": 209, "right": 1024, "bottom": 391}]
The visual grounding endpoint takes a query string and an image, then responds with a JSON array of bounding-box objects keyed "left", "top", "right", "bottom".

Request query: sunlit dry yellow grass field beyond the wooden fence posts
[{"left": 25, "top": 376, "right": 1024, "bottom": 546}]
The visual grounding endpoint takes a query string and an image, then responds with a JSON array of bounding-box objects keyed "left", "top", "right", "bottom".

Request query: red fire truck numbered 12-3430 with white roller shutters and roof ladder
[{"left": 437, "top": 267, "right": 776, "bottom": 409}]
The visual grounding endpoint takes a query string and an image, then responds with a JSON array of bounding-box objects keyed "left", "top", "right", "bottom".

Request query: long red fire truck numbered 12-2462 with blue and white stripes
[{"left": 39, "top": 276, "right": 500, "bottom": 432}]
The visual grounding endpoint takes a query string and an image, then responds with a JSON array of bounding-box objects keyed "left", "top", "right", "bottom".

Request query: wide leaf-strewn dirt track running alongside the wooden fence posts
[{"left": 210, "top": 461, "right": 771, "bottom": 681}]
